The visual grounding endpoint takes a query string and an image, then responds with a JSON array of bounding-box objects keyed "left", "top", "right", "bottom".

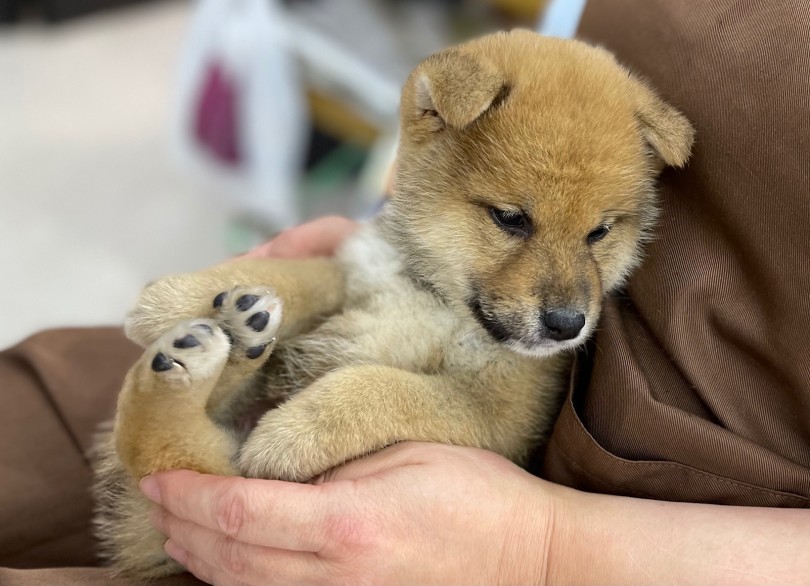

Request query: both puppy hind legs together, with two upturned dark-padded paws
[{"left": 95, "top": 287, "right": 281, "bottom": 578}]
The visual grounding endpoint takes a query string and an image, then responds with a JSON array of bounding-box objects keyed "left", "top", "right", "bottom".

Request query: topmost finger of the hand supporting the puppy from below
[{"left": 141, "top": 470, "right": 339, "bottom": 552}]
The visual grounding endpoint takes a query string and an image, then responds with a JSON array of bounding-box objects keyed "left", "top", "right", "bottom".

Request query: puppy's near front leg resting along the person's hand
[{"left": 239, "top": 359, "right": 560, "bottom": 482}]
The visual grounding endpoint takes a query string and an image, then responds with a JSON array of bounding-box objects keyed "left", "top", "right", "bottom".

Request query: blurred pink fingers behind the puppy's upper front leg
[{"left": 244, "top": 216, "right": 359, "bottom": 258}]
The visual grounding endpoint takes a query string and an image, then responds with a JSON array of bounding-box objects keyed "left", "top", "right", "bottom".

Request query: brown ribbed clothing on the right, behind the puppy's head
[{"left": 544, "top": 0, "right": 810, "bottom": 506}]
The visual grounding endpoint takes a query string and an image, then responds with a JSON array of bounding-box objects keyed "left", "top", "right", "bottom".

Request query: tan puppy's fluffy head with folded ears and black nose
[{"left": 383, "top": 31, "right": 693, "bottom": 356}]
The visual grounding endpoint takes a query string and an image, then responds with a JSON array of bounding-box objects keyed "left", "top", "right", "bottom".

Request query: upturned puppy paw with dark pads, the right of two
[{"left": 212, "top": 287, "right": 282, "bottom": 360}]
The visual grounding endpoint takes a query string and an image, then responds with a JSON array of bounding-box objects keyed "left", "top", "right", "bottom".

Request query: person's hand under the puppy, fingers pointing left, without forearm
[{"left": 141, "top": 443, "right": 553, "bottom": 586}]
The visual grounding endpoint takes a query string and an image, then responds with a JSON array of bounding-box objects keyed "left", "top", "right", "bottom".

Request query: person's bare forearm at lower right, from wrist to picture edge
[{"left": 547, "top": 480, "right": 810, "bottom": 586}]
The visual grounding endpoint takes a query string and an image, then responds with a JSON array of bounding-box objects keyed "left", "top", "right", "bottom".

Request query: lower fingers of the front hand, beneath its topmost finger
[{"left": 152, "top": 507, "right": 328, "bottom": 586}]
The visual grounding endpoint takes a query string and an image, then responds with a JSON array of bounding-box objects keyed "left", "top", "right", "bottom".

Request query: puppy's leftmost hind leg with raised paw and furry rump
[{"left": 94, "top": 320, "right": 238, "bottom": 578}]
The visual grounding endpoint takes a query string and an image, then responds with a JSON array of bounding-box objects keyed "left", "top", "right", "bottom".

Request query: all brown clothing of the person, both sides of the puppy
[{"left": 0, "top": 0, "right": 810, "bottom": 586}]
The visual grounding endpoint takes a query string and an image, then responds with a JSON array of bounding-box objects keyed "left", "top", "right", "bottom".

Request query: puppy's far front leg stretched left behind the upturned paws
[{"left": 125, "top": 258, "right": 345, "bottom": 347}]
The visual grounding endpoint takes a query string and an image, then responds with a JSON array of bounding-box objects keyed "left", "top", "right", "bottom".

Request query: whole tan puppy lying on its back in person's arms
[{"left": 91, "top": 31, "right": 693, "bottom": 577}]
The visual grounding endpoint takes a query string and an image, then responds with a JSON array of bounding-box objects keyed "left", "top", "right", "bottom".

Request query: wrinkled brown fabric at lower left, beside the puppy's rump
[{"left": 0, "top": 328, "right": 200, "bottom": 586}]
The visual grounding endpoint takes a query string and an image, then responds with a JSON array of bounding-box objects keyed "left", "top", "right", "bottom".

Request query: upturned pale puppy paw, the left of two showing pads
[{"left": 144, "top": 319, "right": 230, "bottom": 385}]
